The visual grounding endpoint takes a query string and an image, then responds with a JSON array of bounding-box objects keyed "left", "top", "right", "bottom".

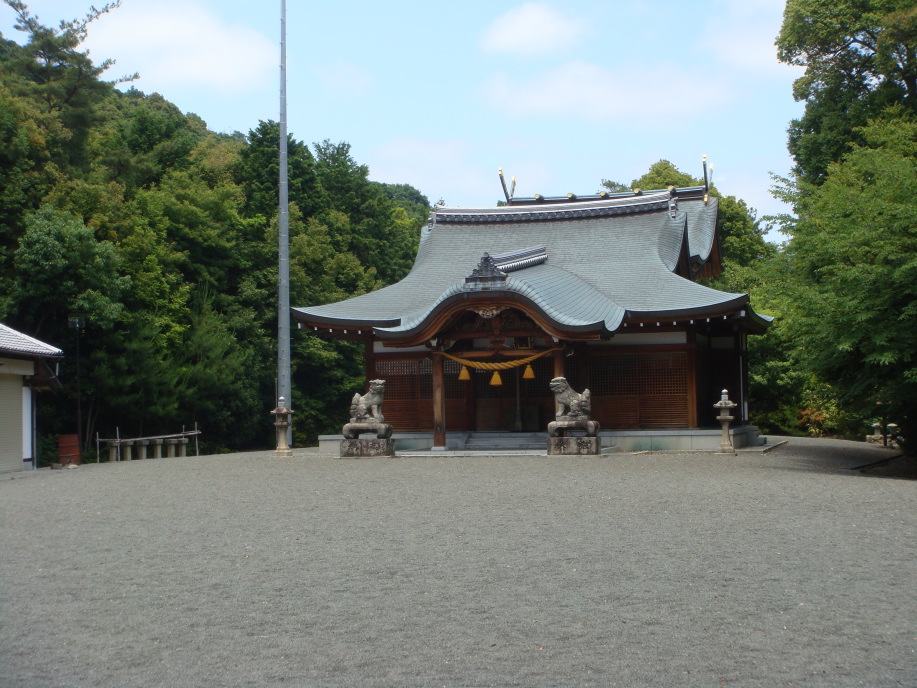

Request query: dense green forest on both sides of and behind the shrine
[{"left": 0, "top": 0, "right": 917, "bottom": 459}]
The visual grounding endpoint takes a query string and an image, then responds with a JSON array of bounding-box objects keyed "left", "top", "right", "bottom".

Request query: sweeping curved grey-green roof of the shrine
[{"left": 293, "top": 192, "right": 760, "bottom": 337}]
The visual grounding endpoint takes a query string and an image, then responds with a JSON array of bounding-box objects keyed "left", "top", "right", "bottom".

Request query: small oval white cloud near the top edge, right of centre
[{"left": 481, "top": 2, "right": 586, "bottom": 55}]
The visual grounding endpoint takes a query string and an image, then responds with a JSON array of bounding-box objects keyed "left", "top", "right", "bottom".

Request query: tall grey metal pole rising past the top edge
[{"left": 277, "top": 0, "right": 293, "bottom": 446}]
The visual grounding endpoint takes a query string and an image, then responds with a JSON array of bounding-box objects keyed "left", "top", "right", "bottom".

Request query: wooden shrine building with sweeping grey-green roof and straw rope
[{"left": 292, "top": 177, "right": 770, "bottom": 449}]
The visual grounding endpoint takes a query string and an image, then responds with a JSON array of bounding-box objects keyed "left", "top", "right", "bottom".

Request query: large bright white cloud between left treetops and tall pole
[{"left": 86, "top": 0, "right": 280, "bottom": 95}]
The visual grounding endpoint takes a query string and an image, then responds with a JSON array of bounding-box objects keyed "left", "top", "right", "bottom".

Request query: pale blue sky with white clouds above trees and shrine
[{"left": 0, "top": 0, "right": 802, "bottom": 231}]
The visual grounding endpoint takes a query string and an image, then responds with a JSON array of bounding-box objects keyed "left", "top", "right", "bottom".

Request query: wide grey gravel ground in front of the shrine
[{"left": 0, "top": 439, "right": 917, "bottom": 688}]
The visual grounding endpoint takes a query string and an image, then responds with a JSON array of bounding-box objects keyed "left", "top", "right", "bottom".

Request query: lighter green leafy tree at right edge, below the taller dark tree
[{"left": 783, "top": 111, "right": 917, "bottom": 436}]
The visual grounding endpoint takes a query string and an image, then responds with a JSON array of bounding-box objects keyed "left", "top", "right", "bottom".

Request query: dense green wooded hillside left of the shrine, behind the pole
[{"left": 0, "top": 0, "right": 429, "bottom": 458}]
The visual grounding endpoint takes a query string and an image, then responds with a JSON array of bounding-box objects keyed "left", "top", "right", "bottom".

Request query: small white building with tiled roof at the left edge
[{"left": 0, "top": 324, "right": 64, "bottom": 473}]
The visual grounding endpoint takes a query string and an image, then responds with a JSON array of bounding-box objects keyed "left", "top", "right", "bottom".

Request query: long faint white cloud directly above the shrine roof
[{"left": 485, "top": 60, "right": 726, "bottom": 126}]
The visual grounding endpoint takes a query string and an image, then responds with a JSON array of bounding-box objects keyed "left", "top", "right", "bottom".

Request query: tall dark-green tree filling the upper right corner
[{"left": 777, "top": 0, "right": 917, "bottom": 184}]
